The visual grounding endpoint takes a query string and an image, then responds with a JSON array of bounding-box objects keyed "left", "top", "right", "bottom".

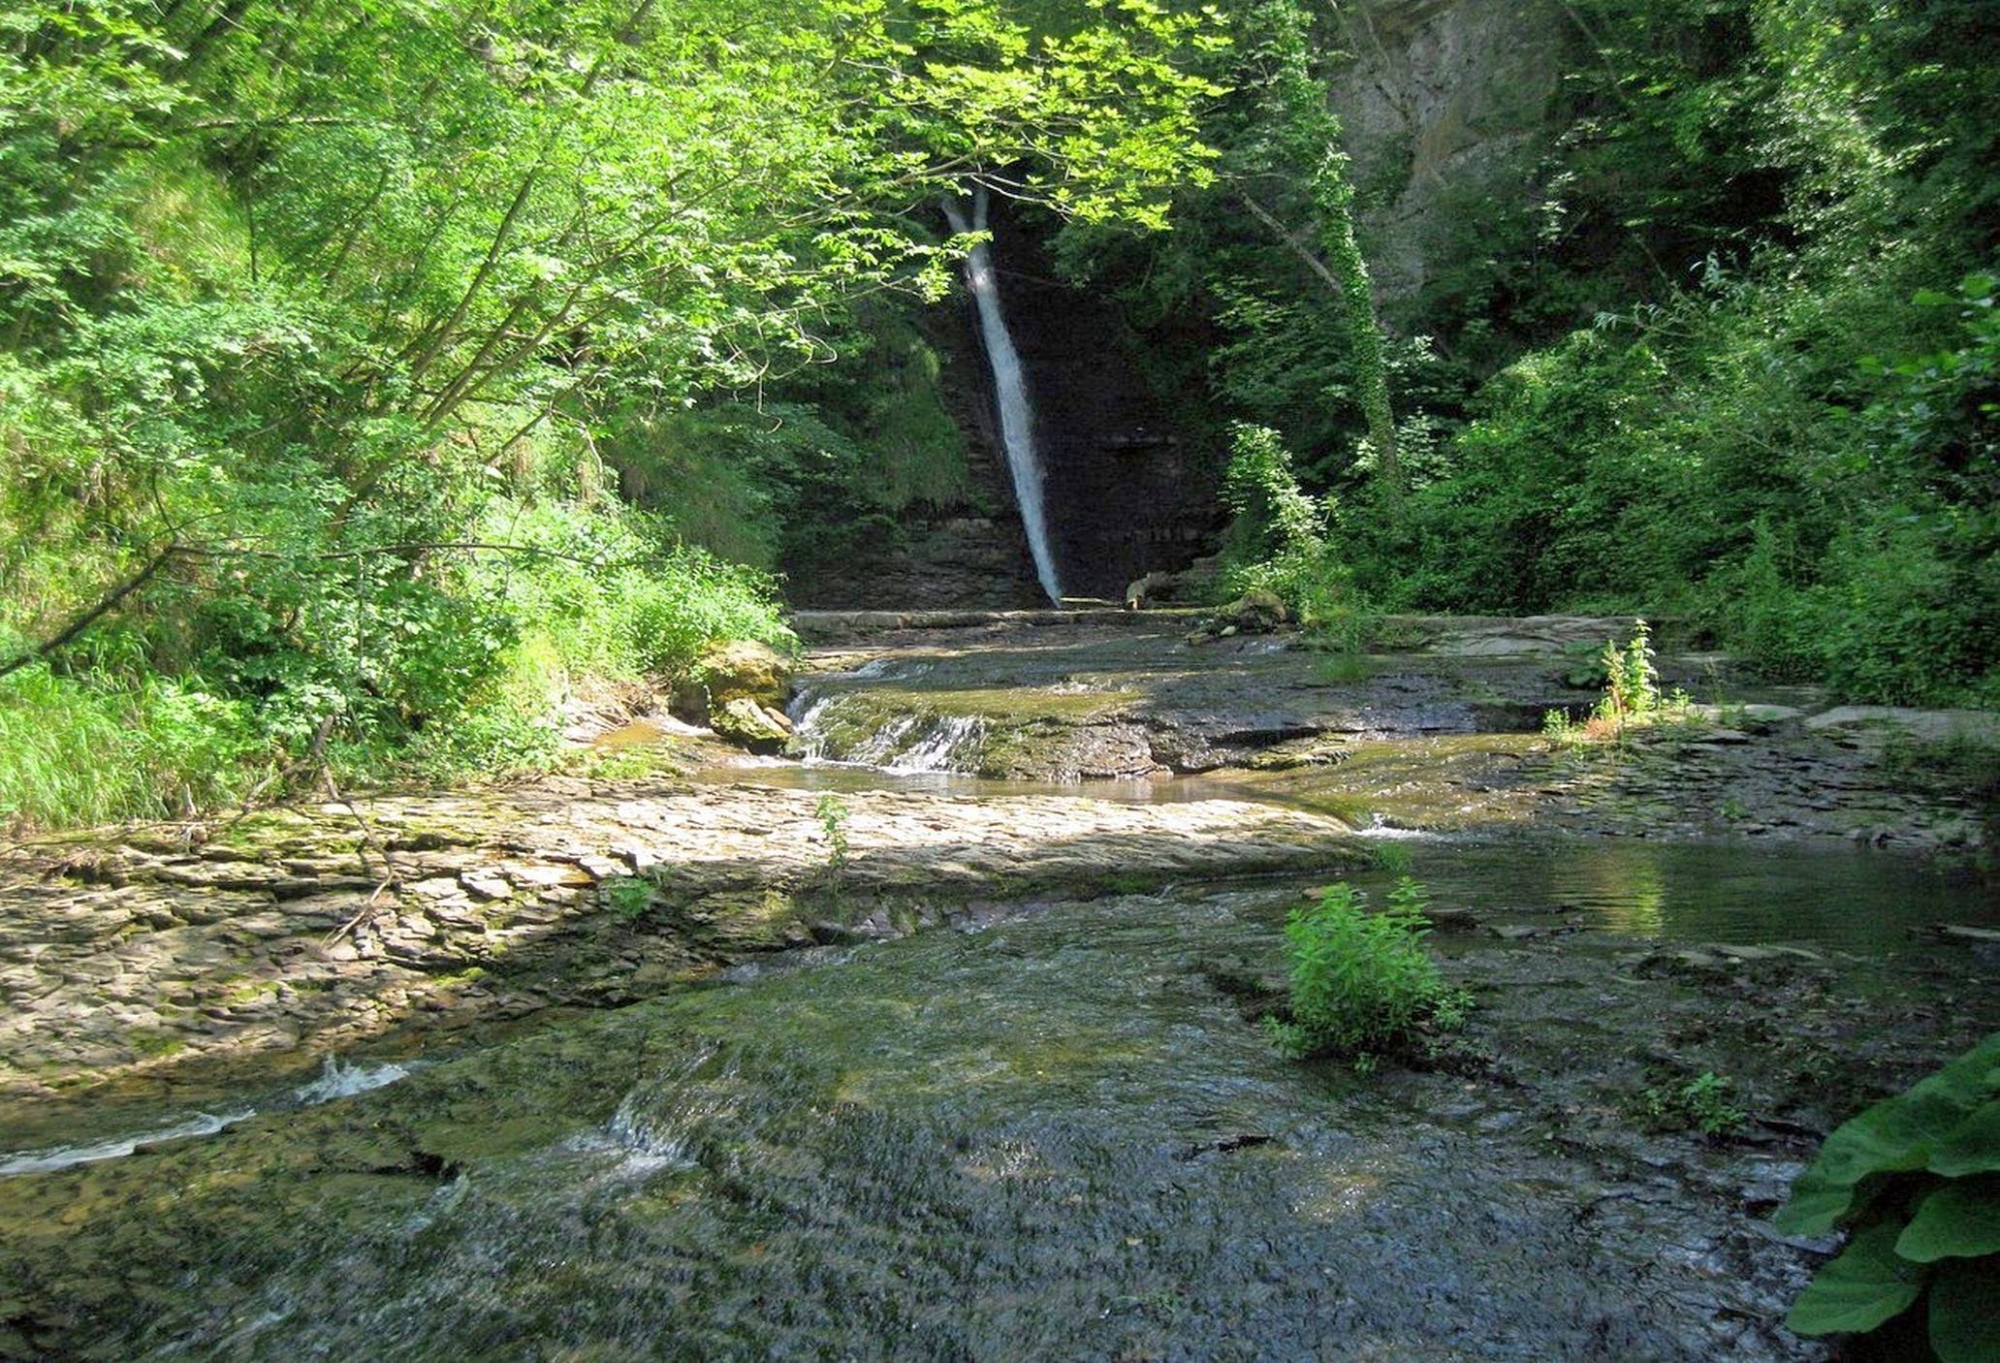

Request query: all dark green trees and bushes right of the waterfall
[{"left": 1168, "top": 0, "right": 2000, "bottom": 703}]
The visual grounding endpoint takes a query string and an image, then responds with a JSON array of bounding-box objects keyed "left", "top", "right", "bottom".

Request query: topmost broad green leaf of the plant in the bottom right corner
[{"left": 1772, "top": 1031, "right": 2000, "bottom": 1235}]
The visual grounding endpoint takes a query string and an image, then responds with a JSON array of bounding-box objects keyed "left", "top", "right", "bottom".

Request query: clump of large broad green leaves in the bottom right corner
[{"left": 1772, "top": 1033, "right": 2000, "bottom": 1363}]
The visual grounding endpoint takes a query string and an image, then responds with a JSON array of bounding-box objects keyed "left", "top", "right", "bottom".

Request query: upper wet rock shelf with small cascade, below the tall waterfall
[{"left": 792, "top": 612, "right": 2000, "bottom": 851}]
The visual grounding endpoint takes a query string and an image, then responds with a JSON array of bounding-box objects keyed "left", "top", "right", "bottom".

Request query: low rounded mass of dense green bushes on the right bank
[{"left": 1358, "top": 257, "right": 2000, "bottom": 703}]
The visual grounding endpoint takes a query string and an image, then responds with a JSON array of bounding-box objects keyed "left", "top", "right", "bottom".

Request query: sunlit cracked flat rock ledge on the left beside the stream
[{"left": 0, "top": 781, "right": 1364, "bottom": 1099}]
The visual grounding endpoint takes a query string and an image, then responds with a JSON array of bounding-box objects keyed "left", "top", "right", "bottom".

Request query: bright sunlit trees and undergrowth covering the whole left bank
[{"left": 0, "top": 0, "right": 1214, "bottom": 823}]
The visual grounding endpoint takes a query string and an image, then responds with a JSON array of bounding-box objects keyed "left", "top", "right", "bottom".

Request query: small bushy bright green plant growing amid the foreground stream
[{"left": 1264, "top": 875, "right": 1468, "bottom": 1059}]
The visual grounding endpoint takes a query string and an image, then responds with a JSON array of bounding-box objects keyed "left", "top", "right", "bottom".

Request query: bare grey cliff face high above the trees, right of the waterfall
[{"left": 1334, "top": 0, "right": 1568, "bottom": 328}]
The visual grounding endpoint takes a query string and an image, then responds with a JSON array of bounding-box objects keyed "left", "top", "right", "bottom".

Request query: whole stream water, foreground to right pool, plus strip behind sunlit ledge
[{"left": 0, "top": 619, "right": 2000, "bottom": 1361}]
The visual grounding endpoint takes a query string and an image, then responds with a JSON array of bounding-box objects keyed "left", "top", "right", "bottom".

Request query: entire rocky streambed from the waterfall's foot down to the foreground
[{"left": 0, "top": 614, "right": 2000, "bottom": 1359}]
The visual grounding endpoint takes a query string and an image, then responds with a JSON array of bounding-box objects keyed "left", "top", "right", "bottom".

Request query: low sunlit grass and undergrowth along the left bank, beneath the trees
[{"left": 0, "top": 498, "right": 796, "bottom": 831}]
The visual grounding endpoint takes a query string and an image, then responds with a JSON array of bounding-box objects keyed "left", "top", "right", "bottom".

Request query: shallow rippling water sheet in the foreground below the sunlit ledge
[{"left": 0, "top": 827, "right": 1990, "bottom": 1359}]
